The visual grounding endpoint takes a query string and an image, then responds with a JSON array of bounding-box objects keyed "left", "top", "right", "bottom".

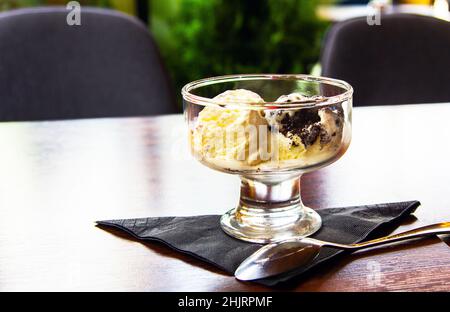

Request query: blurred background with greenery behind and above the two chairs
[{"left": 0, "top": 0, "right": 448, "bottom": 107}]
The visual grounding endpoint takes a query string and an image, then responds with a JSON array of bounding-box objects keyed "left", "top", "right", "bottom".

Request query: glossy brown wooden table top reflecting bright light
[{"left": 0, "top": 104, "right": 450, "bottom": 291}]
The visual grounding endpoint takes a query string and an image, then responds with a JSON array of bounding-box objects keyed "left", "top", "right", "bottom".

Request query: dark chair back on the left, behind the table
[{"left": 0, "top": 7, "right": 177, "bottom": 121}]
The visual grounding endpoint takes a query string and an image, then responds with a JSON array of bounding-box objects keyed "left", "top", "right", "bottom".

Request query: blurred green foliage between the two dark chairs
[{"left": 151, "top": 0, "right": 328, "bottom": 100}]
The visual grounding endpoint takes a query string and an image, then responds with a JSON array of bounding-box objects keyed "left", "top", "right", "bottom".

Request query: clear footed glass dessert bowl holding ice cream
[{"left": 182, "top": 75, "right": 353, "bottom": 243}]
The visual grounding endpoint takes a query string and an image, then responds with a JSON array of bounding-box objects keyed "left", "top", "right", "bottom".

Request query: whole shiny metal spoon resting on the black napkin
[{"left": 234, "top": 222, "right": 450, "bottom": 281}]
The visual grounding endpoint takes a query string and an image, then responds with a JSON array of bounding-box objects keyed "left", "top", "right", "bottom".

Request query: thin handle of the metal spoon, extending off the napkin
[{"left": 345, "top": 222, "right": 450, "bottom": 250}]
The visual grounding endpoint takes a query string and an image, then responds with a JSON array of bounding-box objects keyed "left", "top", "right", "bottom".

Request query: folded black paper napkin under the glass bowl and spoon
[{"left": 97, "top": 201, "right": 420, "bottom": 286}]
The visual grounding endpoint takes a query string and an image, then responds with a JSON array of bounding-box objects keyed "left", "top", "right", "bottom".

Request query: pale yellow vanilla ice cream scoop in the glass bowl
[{"left": 193, "top": 89, "right": 270, "bottom": 166}]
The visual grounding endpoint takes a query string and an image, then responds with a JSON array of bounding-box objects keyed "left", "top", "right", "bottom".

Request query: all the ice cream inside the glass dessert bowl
[{"left": 191, "top": 89, "right": 342, "bottom": 170}]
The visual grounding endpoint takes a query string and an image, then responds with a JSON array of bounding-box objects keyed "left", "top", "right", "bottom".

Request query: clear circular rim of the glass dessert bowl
[{"left": 181, "top": 74, "right": 353, "bottom": 109}]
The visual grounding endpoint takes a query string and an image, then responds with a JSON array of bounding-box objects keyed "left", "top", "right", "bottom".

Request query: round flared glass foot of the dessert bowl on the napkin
[{"left": 220, "top": 207, "right": 322, "bottom": 244}]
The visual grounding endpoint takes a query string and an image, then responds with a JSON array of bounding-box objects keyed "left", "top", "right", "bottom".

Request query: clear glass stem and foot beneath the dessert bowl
[{"left": 221, "top": 176, "right": 321, "bottom": 243}]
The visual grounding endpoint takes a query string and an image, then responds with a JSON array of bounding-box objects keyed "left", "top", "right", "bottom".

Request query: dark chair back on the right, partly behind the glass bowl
[{"left": 321, "top": 14, "right": 450, "bottom": 106}]
